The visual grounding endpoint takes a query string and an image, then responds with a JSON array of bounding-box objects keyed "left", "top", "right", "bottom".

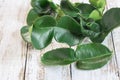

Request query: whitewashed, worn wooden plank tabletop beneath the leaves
[{"left": 0, "top": 0, "right": 120, "bottom": 80}]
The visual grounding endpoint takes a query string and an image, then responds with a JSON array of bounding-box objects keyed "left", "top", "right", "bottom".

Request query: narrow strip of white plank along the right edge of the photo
[{"left": 108, "top": 0, "right": 120, "bottom": 78}]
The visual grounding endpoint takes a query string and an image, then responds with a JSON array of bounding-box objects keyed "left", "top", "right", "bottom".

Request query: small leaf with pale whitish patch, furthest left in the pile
[{"left": 21, "top": 26, "right": 32, "bottom": 43}]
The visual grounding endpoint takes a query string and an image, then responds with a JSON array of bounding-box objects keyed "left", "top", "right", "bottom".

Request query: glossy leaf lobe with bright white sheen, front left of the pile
[{"left": 31, "top": 27, "right": 53, "bottom": 49}]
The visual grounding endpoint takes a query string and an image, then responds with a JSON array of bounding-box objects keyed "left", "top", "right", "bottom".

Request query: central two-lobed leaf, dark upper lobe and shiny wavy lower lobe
[{"left": 54, "top": 16, "right": 84, "bottom": 46}]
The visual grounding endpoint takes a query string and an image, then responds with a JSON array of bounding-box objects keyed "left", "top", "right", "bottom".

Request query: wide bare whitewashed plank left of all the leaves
[{"left": 0, "top": 0, "right": 28, "bottom": 80}]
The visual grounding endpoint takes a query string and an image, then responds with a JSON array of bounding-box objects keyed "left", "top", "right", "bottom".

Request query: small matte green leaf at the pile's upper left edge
[{"left": 27, "top": 9, "right": 40, "bottom": 26}]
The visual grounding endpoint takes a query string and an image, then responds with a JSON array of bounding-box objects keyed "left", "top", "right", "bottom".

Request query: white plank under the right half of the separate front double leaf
[{"left": 72, "top": 0, "right": 119, "bottom": 80}]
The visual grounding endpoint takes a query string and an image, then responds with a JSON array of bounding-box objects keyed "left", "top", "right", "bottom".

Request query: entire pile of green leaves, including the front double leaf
[{"left": 21, "top": 0, "right": 120, "bottom": 70}]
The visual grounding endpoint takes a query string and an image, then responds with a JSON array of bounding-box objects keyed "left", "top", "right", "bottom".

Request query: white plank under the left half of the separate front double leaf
[{"left": 26, "top": 41, "right": 71, "bottom": 80}]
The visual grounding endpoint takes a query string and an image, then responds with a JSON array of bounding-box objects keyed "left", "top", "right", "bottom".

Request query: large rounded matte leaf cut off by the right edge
[{"left": 102, "top": 8, "right": 120, "bottom": 32}]
